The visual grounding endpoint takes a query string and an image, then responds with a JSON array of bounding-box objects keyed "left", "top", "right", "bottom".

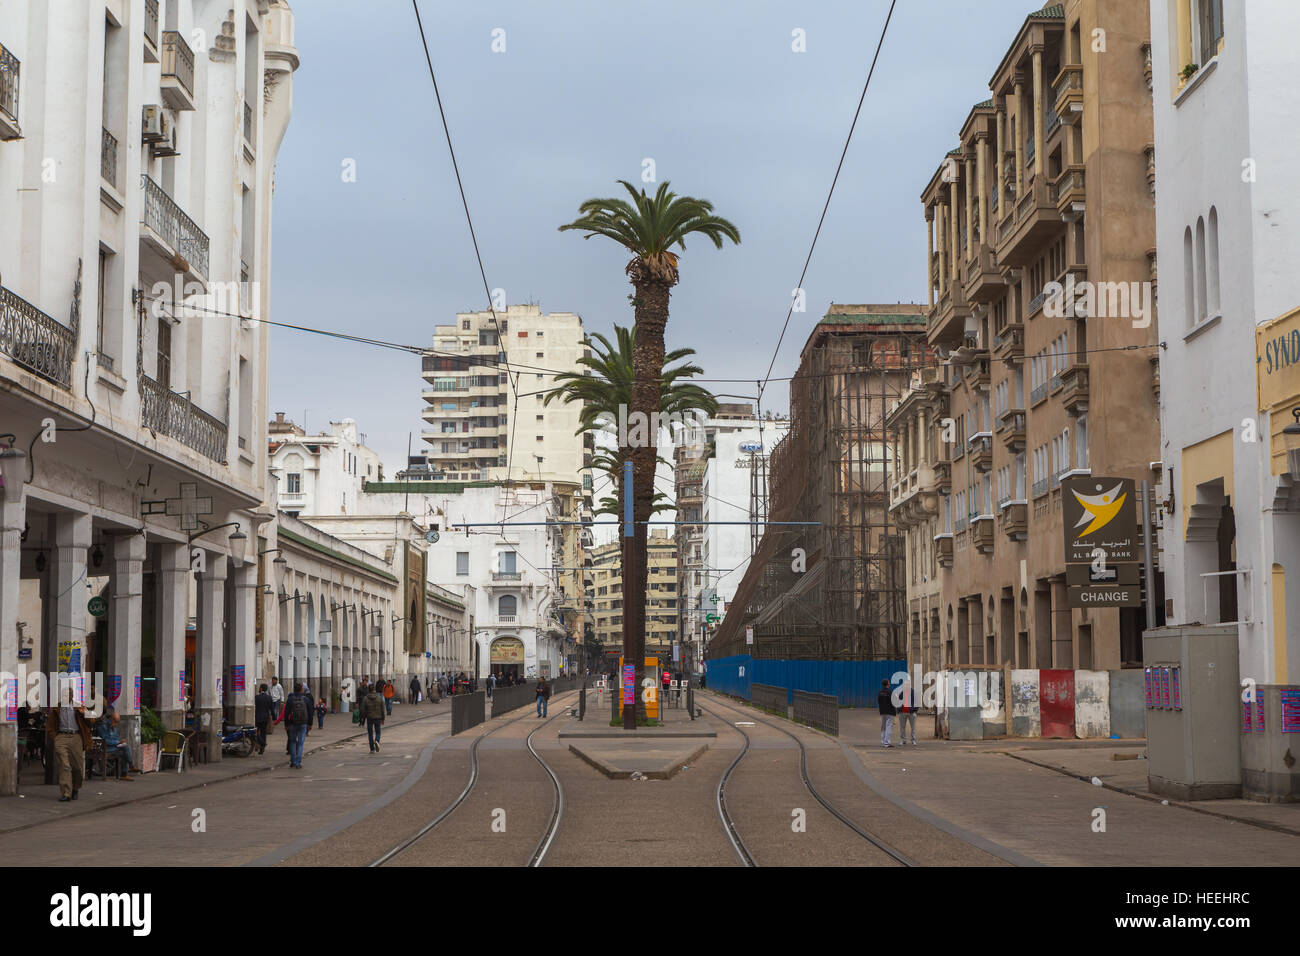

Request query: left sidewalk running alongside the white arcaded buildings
[{"left": 0, "top": 697, "right": 451, "bottom": 834}]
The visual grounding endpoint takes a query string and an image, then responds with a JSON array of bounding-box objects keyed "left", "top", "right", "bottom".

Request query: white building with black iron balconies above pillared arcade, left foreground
[{"left": 0, "top": 0, "right": 298, "bottom": 793}]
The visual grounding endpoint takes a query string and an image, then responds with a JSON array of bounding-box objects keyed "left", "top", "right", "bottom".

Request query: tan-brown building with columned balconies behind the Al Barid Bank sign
[{"left": 915, "top": 0, "right": 1161, "bottom": 669}]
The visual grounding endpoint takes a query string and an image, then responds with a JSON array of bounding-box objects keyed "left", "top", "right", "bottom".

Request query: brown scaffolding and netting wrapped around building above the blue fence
[{"left": 709, "top": 306, "right": 933, "bottom": 661}]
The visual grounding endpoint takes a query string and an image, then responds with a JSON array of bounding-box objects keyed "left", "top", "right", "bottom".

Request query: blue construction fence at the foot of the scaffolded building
[{"left": 705, "top": 654, "right": 907, "bottom": 708}]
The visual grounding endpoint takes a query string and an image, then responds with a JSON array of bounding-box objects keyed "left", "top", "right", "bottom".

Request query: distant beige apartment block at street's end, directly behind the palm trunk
[{"left": 592, "top": 528, "right": 677, "bottom": 661}]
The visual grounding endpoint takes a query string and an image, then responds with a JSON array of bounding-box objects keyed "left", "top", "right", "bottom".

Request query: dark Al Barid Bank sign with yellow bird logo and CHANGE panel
[{"left": 1061, "top": 475, "right": 1141, "bottom": 607}]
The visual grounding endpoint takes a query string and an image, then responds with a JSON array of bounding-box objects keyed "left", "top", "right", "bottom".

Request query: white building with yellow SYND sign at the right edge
[{"left": 1147, "top": 0, "right": 1300, "bottom": 800}]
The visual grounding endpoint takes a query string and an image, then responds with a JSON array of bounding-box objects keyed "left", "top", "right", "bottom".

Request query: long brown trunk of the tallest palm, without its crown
[{"left": 623, "top": 278, "right": 670, "bottom": 728}]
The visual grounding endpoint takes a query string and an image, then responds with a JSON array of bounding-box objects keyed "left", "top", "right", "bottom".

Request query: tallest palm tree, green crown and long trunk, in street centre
[{"left": 560, "top": 179, "right": 740, "bottom": 730}]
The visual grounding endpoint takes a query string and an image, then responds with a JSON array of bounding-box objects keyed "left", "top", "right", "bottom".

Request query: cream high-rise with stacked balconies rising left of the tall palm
[{"left": 421, "top": 304, "right": 595, "bottom": 490}]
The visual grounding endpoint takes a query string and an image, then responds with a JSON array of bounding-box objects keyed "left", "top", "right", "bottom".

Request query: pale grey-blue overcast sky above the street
[{"left": 270, "top": 0, "right": 1043, "bottom": 475}]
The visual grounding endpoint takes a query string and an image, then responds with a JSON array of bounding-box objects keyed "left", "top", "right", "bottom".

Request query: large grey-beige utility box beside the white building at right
[{"left": 1143, "top": 624, "right": 1242, "bottom": 800}]
